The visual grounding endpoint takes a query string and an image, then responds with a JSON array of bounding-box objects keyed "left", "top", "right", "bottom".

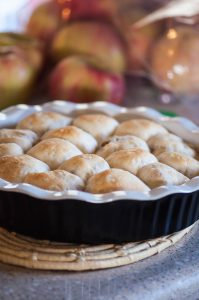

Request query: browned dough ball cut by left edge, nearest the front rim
[{"left": 0, "top": 154, "right": 49, "bottom": 183}]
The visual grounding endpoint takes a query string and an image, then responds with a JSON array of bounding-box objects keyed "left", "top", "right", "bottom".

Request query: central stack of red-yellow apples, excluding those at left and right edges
[{"left": 27, "top": 0, "right": 126, "bottom": 103}]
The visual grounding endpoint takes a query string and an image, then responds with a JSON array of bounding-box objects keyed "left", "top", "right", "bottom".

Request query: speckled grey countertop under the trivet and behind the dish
[{"left": 0, "top": 82, "right": 199, "bottom": 300}]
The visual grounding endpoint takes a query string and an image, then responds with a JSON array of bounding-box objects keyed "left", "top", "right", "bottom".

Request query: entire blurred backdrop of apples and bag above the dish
[{"left": 0, "top": 0, "right": 199, "bottom": 120}]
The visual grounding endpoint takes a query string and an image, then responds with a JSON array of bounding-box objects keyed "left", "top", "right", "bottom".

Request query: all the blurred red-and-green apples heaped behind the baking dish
[{"left": 0, "top": 0, "right": 199, "bottom": 108}]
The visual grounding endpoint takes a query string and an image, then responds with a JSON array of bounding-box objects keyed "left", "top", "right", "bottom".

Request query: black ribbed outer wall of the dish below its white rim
[{"left": 0, "top": 191, "right": 199, "bottom": 244}]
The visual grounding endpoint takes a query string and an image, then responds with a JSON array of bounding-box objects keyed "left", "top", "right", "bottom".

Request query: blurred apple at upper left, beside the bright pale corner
[{"left": 26, "top": 1, "right": 62, "bottom": 46}]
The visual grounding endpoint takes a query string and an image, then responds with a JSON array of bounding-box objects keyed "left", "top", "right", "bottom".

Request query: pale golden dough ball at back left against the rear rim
[{"left": 17, "top": 112, "right": 71, "bottom": 135}]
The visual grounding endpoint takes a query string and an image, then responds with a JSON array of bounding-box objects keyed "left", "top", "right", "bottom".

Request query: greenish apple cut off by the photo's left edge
[{"left": 0, "top": 32, "right": 43, "bottom": 108}]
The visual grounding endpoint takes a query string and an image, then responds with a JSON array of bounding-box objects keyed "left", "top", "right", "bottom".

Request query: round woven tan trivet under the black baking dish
[{"left": 0, "top": 226, "right": 192, "bottom": 271}]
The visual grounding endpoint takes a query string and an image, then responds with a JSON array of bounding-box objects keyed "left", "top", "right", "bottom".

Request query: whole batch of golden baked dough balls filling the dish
[{"left": 0, "top": 112, "right": 199, "bottom": 194}]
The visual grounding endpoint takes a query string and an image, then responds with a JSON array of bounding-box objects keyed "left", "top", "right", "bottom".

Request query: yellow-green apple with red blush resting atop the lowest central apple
[{"left": 51, "top": 21, "right": 126, "bottom": 72}]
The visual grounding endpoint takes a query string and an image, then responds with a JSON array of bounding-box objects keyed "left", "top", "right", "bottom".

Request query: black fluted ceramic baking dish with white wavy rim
[{"left": 0, "top": 101, "right": 199, "bottom": 244}]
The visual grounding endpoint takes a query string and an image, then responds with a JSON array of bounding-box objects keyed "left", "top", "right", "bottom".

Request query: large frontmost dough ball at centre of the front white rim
[{"left": 86, "top": 169, "right": 149, "bottom": 194}]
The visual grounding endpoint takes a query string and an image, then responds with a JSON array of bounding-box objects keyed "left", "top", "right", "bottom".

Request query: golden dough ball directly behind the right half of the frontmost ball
[{"left": 106, "top": 148, "right": 157, "bottom": 175}]
